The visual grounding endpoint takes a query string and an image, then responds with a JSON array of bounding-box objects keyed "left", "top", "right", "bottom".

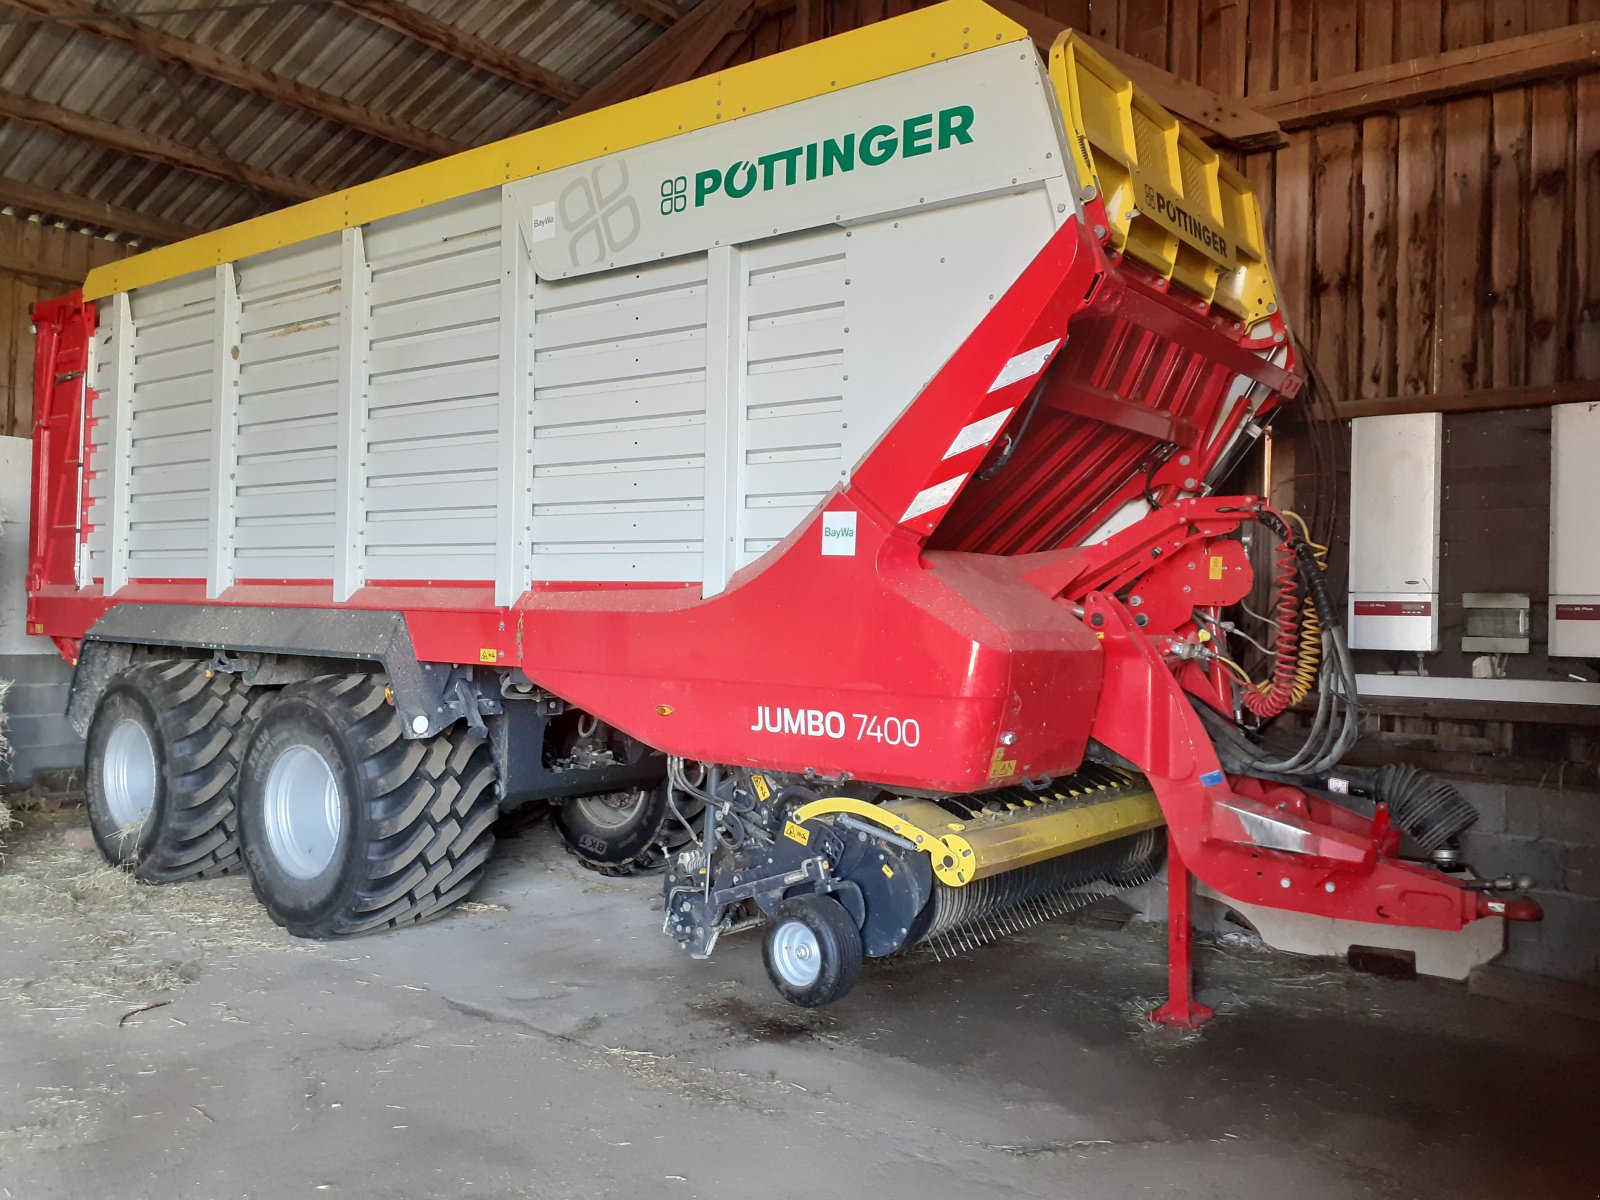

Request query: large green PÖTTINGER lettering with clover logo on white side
[{"left": 661, "top": 104, "right": 973, "bottom": 216}]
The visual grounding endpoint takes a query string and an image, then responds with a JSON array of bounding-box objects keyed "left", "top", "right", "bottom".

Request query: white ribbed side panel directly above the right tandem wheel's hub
[{"left": 234, "top": 237, "right": 341, "bottom": 579}]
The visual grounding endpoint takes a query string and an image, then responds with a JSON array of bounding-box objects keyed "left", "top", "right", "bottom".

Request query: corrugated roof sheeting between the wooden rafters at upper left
[{"left": 0, "top": 0, "right": 681, "bottom": 244}]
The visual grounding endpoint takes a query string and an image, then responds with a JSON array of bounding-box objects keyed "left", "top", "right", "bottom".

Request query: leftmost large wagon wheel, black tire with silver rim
[{"left": 85, "top": 659, "right": 269, "bottom": 883}]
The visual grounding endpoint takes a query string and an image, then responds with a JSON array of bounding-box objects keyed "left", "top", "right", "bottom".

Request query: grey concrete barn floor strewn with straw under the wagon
[{"left": 0, "top": 814, "right": 1600, "bottom": 1200}]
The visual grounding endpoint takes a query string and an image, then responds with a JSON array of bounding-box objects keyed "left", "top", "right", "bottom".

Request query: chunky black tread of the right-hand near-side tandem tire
[{"left": 254, "top": 675, "right": 499, "bottom": 938}]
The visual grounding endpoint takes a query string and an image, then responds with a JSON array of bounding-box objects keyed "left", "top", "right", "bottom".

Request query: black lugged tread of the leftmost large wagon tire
[{"left": 120, "top": 659, "right": 270, "bottom": 883}]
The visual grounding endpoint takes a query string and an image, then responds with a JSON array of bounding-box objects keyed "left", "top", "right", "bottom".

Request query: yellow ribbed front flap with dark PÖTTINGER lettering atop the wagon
[{"left": 1050, "top": 30, "right": 1278, "bottom": 323}]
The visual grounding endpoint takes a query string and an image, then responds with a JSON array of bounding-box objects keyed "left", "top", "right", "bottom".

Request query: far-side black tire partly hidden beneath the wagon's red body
[{"left": 550, "top": 781, "right": 706, "bottom": 875}]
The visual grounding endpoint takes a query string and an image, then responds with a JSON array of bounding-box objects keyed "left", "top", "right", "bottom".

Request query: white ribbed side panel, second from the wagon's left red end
[{"left": 125, "top": 272, "right": 216, "bottom": 579}]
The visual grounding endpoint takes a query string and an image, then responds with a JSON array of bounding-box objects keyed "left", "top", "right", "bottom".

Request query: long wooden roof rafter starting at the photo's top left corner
[{"left": 0, "top": 0, "right": 467, "bottom": 157}]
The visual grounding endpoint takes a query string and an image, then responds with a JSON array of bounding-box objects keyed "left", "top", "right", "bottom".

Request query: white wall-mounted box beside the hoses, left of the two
[{"left": 1350, "top": 413, "right": 1443, "bottom": 651}]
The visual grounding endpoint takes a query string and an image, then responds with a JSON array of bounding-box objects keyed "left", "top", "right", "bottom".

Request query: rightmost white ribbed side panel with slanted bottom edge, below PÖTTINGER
[{"left": 736, "top": 229, "right": 850, "bottom": 566}]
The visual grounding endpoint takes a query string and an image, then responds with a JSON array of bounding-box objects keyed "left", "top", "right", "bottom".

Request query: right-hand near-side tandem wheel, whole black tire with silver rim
[{"left": 238, "top": 675, "right": 499, "bottom": 938}]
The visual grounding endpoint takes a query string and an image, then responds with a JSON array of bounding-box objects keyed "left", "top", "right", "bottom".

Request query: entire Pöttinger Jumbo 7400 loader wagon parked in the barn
[{"left": 29, "top": 0, "right": 1536, "bottom": 1021}]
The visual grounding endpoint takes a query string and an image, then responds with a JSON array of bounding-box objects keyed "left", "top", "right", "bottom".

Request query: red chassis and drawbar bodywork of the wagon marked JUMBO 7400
[{"left": 29, "top": 216, "right": 1522, "bottom": 1019}]
